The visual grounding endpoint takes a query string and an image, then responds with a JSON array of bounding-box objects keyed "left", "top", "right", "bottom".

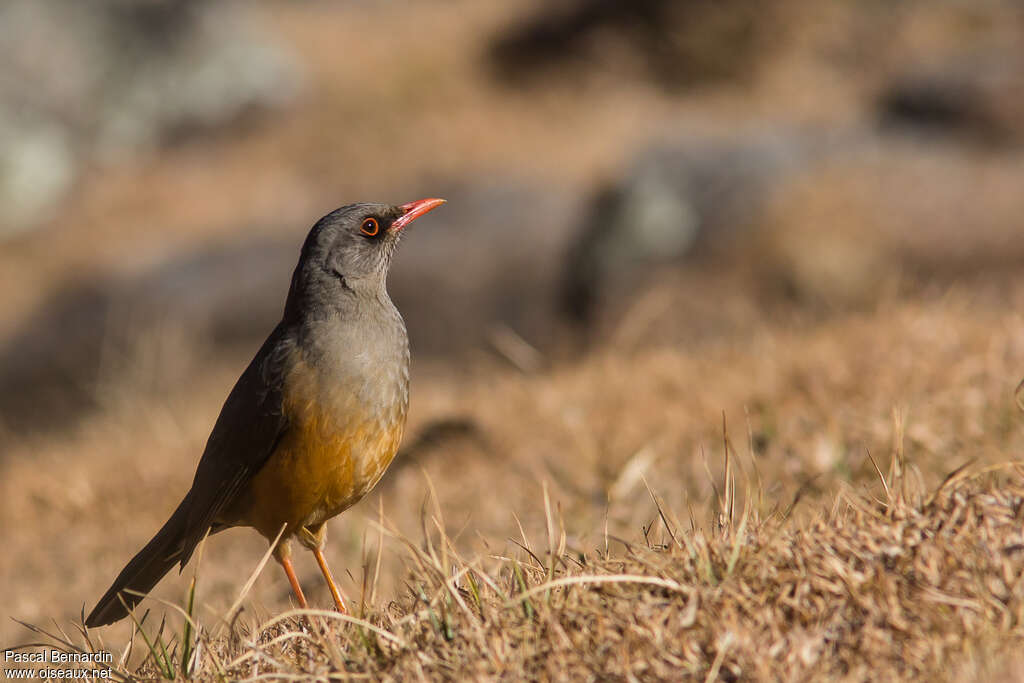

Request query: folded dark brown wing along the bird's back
[{"left": 180, "top": 324, "right": 296, "bottom": 567}]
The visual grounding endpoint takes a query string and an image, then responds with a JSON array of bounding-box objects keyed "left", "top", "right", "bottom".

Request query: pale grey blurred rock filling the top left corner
[{"left": 0, "top": 0, "right": 298, "bottom": 237}]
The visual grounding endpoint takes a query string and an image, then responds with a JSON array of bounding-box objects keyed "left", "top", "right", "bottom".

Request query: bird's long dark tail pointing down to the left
[{"left": 85, "top": 496, "right": 189, "bottom": 627}]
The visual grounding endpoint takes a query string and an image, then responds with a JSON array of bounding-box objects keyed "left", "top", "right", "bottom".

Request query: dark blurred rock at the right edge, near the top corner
[{"left": 879, "top": 46, "right": 1024, "bottom": 145}]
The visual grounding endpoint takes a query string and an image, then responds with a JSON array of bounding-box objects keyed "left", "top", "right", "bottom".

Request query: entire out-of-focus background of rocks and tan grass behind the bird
[{"left": 0, "top": 0, "right": 1024, "bottom": 640}]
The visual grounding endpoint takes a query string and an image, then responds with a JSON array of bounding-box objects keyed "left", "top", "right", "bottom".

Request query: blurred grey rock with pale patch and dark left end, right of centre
[{"left": 561, "top": 130, "right": 826, "bottom": 324}]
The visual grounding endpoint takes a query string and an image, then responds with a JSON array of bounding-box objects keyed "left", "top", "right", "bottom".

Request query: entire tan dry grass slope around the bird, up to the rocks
[{"left": 6, "top": 278, "right": 1024, "bottom": 680}]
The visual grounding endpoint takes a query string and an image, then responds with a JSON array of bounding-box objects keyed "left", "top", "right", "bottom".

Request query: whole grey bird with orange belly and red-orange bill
[{"left": 85, "top": 199, "right": 444, "bottom": 627}]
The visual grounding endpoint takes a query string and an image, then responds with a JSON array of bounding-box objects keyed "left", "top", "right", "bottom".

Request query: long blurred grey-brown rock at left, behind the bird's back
[{"left": 0, "top": 237, "right": 297, "bottom": 433}]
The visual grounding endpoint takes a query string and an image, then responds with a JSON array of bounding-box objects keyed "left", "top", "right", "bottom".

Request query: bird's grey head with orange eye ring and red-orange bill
[{"left": 285, "top": 199, "right": 444, "bottom": 319}]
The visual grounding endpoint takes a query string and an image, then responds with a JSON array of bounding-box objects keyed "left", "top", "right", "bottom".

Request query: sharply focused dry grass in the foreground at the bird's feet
[{"left": 12, "top": 452, "right": 1024, "bottom": 680}]
